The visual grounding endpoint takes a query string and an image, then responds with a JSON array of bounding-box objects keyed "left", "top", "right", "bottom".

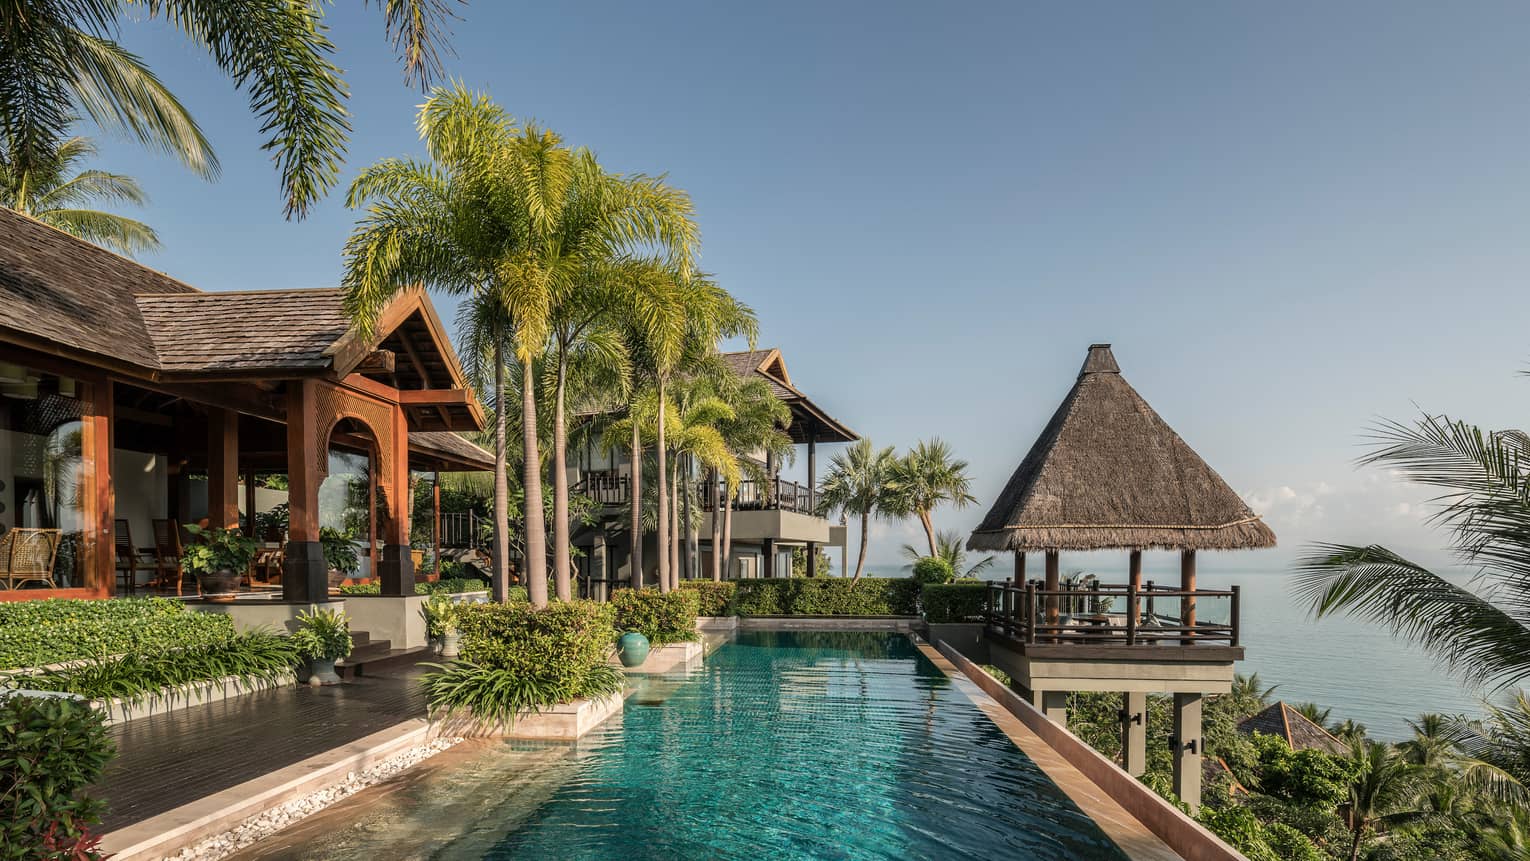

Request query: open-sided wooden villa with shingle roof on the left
[{"left": 0, "top": 210, "right": 493, "bottom": 603}]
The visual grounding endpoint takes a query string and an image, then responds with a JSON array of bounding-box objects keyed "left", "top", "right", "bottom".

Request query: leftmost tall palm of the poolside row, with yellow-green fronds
[{"left": 343, "top": 87, "right": 560, "bottom": 606}]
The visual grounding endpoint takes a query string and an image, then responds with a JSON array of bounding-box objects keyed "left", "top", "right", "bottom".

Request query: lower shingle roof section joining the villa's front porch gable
[{"left": 135, "top": 289, "right": 350, "bottom": 373}]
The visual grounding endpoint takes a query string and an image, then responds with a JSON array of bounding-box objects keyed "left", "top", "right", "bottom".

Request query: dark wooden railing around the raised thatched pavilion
[{"left": 985, "top": 580, "right": 1239, "bottom": 645}]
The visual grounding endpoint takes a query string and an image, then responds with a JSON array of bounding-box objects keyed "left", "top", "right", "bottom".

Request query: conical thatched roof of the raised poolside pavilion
[{"left": 967, "top": 344, "right": 1274, "bottom": 551}]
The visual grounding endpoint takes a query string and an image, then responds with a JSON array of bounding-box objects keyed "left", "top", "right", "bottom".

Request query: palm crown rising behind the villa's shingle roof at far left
[{"left": 0, "top": 138, "right": 159, "bottom": 254}]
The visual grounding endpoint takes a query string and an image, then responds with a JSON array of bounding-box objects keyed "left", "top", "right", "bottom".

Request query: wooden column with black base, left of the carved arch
[{"left": 282, "top": 379, "right": 329, "bottom": 603}]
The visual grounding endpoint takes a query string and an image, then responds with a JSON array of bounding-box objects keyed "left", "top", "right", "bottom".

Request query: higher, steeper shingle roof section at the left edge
[{"left": 0, "top": 208, "right": 199, "bottom": 369}]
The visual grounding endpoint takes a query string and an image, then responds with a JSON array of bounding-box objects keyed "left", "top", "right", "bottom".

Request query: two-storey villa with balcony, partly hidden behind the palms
[{"left": 569, "top": 349, "right": 858, "bottom": 598}]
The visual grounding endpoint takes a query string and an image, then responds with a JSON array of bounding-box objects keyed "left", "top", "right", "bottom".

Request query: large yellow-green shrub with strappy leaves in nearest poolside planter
[{"left": 422, "top": 601, "right": 626, "bottom": 722}]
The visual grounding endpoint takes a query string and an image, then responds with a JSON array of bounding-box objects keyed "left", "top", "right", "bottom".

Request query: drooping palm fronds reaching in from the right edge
[{"left": 1296, "top": 416, "right": 1530, "bottom": 687}]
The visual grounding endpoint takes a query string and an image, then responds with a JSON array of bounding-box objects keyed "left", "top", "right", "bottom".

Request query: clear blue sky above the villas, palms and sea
[{"left": 86, "top": 0, "right": 1530, "bottom": 569}]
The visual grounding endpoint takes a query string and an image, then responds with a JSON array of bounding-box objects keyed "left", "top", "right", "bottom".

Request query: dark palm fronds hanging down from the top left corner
[{"left": 0, "top": 0, "right": 451, "bottom": 217}]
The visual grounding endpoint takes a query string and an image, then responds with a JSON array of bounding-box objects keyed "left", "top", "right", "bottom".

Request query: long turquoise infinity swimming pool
[{"left": 235, "top": 632, "right": 1125, "bottom": 861}]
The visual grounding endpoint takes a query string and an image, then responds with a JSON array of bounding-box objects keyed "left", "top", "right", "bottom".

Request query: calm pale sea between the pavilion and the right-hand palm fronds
[{"left": 1201, "top": 572, "right": 1483, "bottom": 740}]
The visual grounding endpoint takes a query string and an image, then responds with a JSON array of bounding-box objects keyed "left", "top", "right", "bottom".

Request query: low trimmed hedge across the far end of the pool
[{"left": 733, "top": 577, "right": 920, "bottom": 616}]
